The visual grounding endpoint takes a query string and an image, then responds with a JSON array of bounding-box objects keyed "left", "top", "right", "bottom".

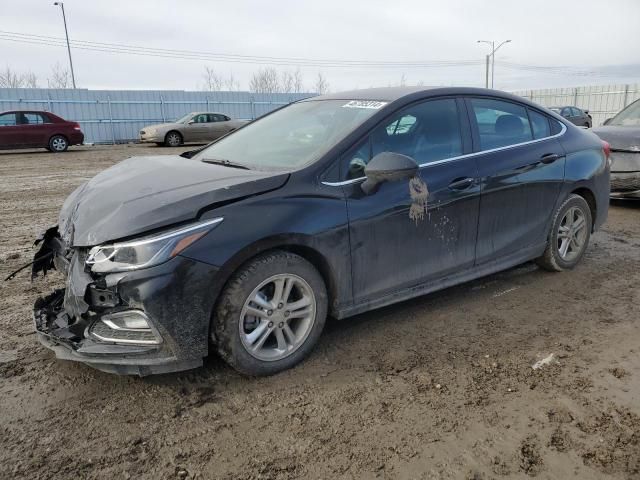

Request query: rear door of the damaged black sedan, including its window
[{"left": 467, "top": 97, "right": 565, "bottom": 264}]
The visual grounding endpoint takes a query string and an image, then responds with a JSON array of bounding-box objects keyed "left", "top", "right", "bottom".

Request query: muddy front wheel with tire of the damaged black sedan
[{"left": 212, "top": 251, "right": 328, "bottom": 376}]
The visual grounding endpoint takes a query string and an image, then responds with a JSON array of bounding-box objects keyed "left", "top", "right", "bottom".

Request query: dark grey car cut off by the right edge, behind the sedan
[{"left": 593, "top": 100, "right": 640, "bottom": 198}]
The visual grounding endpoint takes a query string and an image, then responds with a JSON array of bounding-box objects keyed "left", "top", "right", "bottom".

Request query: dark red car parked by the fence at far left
[{"left": 0, "top": 110, "right": 84, "bottom": 153}]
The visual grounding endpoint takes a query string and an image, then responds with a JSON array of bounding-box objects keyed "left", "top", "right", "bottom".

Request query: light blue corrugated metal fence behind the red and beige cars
[{"left": 0, "top": 88, "right": 314, "bottom": 143}]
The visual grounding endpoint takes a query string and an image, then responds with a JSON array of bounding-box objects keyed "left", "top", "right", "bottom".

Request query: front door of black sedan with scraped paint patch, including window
[{"left": 341, "top": 98, "right": 480, "bottom": 303}]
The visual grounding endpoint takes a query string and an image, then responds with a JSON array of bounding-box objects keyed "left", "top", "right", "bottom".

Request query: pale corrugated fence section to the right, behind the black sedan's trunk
[{"left": 513, "top": 83, "right": 640, "bottom": 127}]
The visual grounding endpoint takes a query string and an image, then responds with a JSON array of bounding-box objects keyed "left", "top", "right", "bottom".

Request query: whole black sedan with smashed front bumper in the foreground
[{"left": 33, "top": 87, "right": 609, "bottom": 375}]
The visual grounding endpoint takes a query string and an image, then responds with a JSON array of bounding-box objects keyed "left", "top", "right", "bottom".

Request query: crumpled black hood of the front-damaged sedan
[{"left": 58, "top": 155, "right": 289, "bottom": 247}]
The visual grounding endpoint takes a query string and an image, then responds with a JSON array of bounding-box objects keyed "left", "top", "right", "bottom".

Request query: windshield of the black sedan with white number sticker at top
[{"left": 194, "top": 100, "right": 385, "bottom": 170}]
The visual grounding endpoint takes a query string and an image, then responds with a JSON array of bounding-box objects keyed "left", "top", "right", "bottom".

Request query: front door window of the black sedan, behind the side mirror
[{"left": 343, "top": 98, "right": 462, "bottom": 179}]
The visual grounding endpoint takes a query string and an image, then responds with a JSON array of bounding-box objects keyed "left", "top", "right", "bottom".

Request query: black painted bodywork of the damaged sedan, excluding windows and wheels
[{"left": 31, "top": 88, "right": 609, "bottom": 375}]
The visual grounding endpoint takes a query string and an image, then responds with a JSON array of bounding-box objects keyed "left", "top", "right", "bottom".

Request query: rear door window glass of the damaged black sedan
[{"left": 471, "top": 98, "right": 533, "bottom": 150}]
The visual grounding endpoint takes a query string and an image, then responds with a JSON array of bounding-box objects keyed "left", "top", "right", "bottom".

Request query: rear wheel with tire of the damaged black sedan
[{"left": 536, "top": 194, "right": 593, "bottom": 272}]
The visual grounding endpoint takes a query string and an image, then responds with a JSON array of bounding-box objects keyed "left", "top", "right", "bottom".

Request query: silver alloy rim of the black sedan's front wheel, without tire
[{"left": 239, "top": 274, "right": 316, "bottom": 361}]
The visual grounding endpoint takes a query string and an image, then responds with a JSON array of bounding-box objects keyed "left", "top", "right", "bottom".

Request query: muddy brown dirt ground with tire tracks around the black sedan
[{"left": 0, "top": 146, "right": 640, "bottom": 479}]
